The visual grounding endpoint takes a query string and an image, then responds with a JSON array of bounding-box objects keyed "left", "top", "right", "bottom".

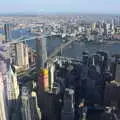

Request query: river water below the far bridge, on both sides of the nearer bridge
[{"left": 28, "top": 38, "right": 120, "bottom": 58}]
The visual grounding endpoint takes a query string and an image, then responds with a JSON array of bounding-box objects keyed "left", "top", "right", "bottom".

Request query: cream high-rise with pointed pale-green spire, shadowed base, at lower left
[{"left": 0, "top": 65, "right": 19, "bottom": 118}]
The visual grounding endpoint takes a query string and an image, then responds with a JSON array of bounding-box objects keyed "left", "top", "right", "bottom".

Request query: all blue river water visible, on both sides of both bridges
[{"left": 0, "top": 29, "right": 120, "bottom": 58}]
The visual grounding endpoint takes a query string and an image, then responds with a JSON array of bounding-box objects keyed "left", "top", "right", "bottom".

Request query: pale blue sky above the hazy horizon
[{"left": 0, "top": 0, "right": 120, "bottom": 13}]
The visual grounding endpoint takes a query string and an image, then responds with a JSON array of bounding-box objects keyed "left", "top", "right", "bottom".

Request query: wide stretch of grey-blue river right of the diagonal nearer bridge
[{"left": 63, "top": 42, "right": 120, "bottom": 58}]
